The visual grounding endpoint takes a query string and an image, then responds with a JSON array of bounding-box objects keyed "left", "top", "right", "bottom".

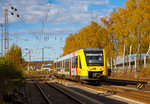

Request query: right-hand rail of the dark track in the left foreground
[{"left": 46, "top": 83, "right": 85, "bottom": 104}]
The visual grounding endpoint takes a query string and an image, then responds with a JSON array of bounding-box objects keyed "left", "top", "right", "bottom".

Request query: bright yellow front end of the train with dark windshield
[{"left": 81, "top": 48, "right": 108, "bottom": 81}]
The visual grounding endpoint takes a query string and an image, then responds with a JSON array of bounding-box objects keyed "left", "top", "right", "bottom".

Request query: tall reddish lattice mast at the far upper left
[{"left": 4, "top": 9, "right": 9, "bottom": 54}]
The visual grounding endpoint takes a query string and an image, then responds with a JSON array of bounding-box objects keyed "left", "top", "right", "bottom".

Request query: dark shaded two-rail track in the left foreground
[{"left": 29, "top": 78, "right": 85, "bottom": 104}]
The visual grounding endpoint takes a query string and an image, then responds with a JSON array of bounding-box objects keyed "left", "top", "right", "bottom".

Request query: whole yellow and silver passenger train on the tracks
[{"left": 54, "top": 48, "right": 108, "bottom": 81}]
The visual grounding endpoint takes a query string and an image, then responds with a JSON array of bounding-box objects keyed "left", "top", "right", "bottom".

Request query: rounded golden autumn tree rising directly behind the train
[{"left": 63, "top": 21, "right": 110, "bottom": 55}]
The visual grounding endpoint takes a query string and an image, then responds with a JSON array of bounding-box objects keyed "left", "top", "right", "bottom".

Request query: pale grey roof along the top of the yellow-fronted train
[{"left": 54, "top": 48, "right": 103, "bottom": 62}]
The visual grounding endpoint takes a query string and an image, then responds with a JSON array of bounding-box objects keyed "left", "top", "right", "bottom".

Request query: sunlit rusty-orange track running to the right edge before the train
[{"left": 56, "top": 80, "right": 150, "bottom": 103}]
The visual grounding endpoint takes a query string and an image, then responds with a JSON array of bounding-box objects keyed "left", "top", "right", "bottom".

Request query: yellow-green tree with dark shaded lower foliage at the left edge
[{"left": 0, "top": 45, "right": 25, "bottom": 94}]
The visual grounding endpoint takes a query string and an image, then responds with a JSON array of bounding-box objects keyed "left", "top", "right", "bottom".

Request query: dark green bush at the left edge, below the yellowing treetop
[{"left": 0, "top": 58, "right": 23, "bottom": 93}]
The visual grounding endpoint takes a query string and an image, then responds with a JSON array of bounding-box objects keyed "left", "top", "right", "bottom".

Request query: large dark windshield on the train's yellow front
[{"left": 84, "top": 51, "right": 103, "bottom": 66}]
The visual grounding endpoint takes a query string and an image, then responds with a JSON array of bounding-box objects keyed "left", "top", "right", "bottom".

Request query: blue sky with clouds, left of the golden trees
[{"left": 0, "top": 0, "right": 127, "bottom": 61}]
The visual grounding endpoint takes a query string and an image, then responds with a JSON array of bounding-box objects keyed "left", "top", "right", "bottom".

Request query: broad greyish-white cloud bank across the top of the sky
[{"left": 0, "top": 0, "right": 109, "bottom": 25}]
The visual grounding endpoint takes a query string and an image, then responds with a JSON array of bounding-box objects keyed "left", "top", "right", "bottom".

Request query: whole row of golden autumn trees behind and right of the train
[{"left": 63, "top": 0, "right": 150, "bottom": 66}]
